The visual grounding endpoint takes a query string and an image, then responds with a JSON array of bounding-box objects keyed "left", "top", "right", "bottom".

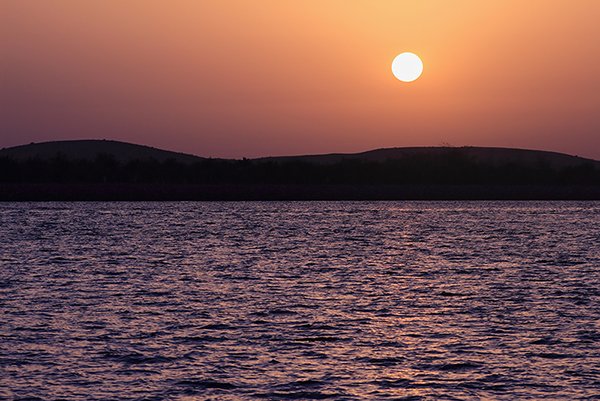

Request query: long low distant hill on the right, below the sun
[{"left": 259, "top": 146, "right": 600, "bottom": 169}]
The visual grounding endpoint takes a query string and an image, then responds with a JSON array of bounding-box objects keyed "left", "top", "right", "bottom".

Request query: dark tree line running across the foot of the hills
[{"left": 0, "top": 152, "right": 600, "bottom": 185}]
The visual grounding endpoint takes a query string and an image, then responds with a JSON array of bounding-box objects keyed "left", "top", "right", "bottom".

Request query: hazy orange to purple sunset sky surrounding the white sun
[{"left": 0, "top": 0, "right": 600, "bottom": 159}]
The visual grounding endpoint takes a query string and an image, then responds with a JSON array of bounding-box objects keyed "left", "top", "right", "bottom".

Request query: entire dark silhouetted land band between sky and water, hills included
[{"left": 0, "top": 141, "right": 600, "bottom": 200}]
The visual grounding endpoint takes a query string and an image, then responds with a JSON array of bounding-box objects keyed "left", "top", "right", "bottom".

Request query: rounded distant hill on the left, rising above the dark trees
[{"left": 0, "top": 140, "right": 202, "bottom": 163}]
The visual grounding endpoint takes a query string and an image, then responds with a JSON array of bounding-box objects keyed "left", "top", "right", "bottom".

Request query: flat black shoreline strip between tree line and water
[{"left": 0, "top": 183, "right": 600, "bottom": 202}]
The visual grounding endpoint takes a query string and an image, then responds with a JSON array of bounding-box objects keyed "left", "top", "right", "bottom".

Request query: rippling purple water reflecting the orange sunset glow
[{"left": 0, "top": 202, "right": 600, "bottom": 400}]
